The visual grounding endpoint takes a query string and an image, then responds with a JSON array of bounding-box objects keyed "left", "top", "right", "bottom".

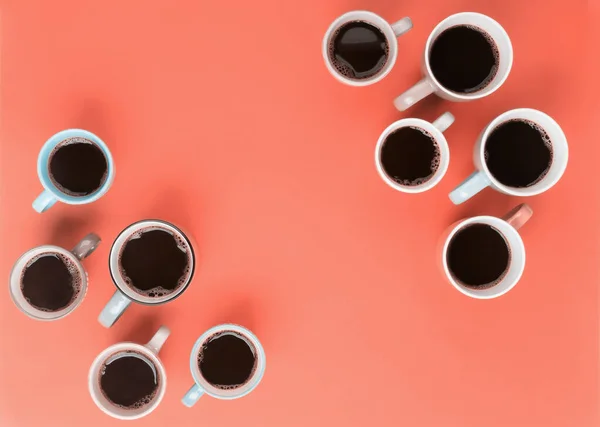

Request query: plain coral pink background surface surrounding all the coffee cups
[{"left": 0, "top": 0, "right": 600, "bottom": 427}]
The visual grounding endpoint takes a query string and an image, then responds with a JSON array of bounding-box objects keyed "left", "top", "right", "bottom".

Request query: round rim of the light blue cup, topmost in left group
[{"left": 37, "top": 128, "right": 115, "bottom": 205}]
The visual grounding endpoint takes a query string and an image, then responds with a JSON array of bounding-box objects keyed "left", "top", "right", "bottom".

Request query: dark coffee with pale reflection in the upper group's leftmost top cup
[{"left": 330, "top": 21, "right": 389, "bottom": 79}]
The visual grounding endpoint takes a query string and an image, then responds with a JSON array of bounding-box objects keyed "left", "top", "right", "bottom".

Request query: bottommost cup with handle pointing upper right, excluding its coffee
[{"left": 88, "top": 326, "right": 171, "bottom": 420}]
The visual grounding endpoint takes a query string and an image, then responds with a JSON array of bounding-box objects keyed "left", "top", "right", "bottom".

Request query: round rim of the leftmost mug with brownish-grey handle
[{"left": 8, "top": 245, "right": 88, "bottom": 322}]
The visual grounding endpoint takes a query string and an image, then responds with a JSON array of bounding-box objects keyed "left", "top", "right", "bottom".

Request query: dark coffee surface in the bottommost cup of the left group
[{"left": 100, "top": 356, "right": 158, "bottom": 409}]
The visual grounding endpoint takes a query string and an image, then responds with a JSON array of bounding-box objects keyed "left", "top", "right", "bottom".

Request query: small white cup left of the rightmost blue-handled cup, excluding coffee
[{"left": 375, "top": 112, "right": 454, "bottom": 193}]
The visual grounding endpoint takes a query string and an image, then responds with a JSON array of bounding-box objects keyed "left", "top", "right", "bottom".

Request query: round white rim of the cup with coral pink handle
[{"left": 442, "top": 215, "right": 527, "bottom": 299}]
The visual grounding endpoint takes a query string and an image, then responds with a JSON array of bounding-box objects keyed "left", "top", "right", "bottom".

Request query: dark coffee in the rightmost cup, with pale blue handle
[{"left": 485, "top": 120, "right": 552, "bottom": 188}]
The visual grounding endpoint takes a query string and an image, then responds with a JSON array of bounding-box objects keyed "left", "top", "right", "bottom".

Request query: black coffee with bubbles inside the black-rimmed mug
[{"left": 119, "top": 226, "right": 192, "bottom": 298}]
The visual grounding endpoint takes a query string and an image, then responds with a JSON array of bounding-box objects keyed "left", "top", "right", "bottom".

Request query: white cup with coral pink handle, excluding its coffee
[{"left": 438, "top": 204, "right": 533, "bottom": 299}]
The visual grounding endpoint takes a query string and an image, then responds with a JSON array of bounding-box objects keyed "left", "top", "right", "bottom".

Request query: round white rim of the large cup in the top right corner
[{"left": 423, "top": 12, "right": 514, "bottom": 101}]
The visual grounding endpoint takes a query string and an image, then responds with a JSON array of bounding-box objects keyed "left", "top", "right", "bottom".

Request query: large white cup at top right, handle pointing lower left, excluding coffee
[{"left": 394, "top": 12, "right": 513, "bottom": 111}]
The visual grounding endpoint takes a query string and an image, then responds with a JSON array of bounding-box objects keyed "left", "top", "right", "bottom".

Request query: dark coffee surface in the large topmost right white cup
[{"left": 429, "top": 25, "right": 498, "bottom": 93}]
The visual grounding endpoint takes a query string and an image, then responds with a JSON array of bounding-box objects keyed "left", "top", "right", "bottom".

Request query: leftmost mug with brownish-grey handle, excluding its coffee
[{"left": 9, "top": 233, "right": 100, "bottom": 321}]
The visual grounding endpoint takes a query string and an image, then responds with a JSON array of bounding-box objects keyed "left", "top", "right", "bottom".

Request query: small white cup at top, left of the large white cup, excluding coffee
[{"left": 322, "top": 10, "right": 412, "bottom": 86}]
